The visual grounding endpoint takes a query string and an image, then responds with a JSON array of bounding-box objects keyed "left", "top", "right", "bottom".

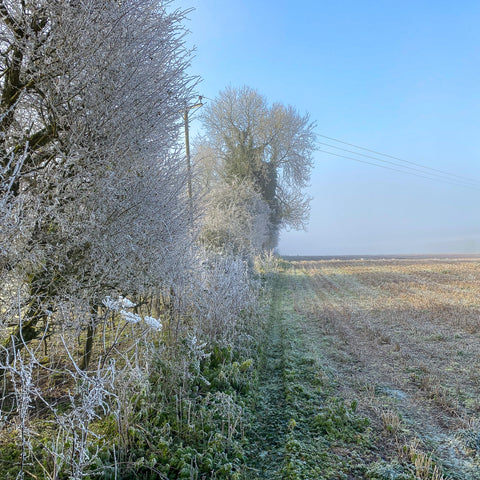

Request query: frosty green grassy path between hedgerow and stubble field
[{"left": 249, "top": 275, "right": 376, "bottom": 480}]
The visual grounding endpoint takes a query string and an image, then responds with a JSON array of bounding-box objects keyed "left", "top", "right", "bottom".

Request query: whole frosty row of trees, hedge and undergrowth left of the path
[{"left": 0, "top": 0, "right": 314, "bottom": 479}]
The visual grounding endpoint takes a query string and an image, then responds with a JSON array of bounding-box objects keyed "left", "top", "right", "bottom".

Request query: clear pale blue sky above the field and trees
[{"left": 185, "top": 0, "right": 480, "bottom": 255}]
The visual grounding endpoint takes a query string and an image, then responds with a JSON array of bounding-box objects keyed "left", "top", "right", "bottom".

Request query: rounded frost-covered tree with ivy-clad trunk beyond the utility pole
[{"left": 199, "top": 87, "right": 315, "bottom": 248}]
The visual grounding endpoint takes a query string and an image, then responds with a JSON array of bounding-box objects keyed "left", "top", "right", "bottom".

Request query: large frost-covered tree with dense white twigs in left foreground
[{"left": 0, "top": 0, "right": 192, "bottom": 364}]
